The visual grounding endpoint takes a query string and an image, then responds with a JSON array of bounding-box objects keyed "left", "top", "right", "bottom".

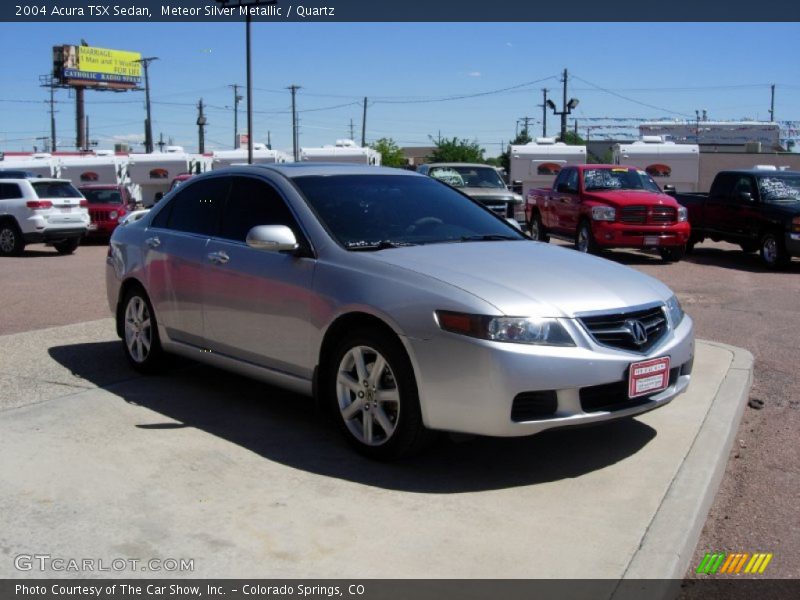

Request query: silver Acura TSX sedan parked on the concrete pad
[{"left": 107, "top": 164, "right": 694, "bottom": 459}]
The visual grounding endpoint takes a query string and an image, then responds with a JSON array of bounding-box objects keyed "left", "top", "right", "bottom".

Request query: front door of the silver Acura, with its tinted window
[{"left": 203, "top": 176, "right": 316, "bottom": 379}]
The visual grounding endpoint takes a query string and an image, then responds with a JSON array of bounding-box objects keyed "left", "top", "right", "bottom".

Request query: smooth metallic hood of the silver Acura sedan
[{"left": 370, "top": 240, "right": 672, "bottom": 317}]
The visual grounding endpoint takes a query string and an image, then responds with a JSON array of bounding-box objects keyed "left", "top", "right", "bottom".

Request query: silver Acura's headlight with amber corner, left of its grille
[{"left": 436, "top": 310, "right": 575, "bottom": 346}]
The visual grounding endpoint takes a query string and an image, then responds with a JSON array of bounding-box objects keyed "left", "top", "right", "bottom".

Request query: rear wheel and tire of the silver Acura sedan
[{"left": 117, "top": 287, "right": 165, "bottom": 373}]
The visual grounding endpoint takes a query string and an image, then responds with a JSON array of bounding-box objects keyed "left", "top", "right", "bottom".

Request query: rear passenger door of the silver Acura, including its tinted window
[{"left": 143, "top": 177, "right": 230, "bottom": 348}]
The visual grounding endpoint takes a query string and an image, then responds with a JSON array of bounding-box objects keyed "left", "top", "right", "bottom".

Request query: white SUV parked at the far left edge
[{"left": 0, "top": 178, "right": 89, "bottom": 256}]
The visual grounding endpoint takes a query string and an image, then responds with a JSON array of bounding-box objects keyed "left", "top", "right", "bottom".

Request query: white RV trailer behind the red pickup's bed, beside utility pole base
[{"left": 509, "top": 138, "right": 586, "bottom": 198}]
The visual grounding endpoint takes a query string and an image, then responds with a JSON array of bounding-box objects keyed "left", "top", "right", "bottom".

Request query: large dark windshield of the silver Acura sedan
[{"left": 294, "top": 175, "right": 525, "bottom": 250}]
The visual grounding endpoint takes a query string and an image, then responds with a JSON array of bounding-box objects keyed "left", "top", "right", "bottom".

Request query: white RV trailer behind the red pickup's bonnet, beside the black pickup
[{"left": 614, "top": 135, "right": 700, "bottom": 192}]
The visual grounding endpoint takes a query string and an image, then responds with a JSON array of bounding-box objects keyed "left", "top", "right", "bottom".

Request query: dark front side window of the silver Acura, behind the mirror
[{"left": 219, "top": 177, "right": 298, "bottom": 242}]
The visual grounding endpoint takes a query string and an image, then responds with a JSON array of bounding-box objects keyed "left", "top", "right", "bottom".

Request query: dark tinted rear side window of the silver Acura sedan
[{"left": 158, "top": 177, "right": 230, "bottom": 235}]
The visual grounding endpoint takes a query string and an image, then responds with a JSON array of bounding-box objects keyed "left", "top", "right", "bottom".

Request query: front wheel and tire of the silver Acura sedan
[{"left": 323, "top": 329, "right": 433, "bottom": 460}]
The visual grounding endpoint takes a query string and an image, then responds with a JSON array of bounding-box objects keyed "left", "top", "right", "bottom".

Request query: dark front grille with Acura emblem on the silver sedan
[{"left": 578, "top": 306, "right": 667, "bottom": 352}]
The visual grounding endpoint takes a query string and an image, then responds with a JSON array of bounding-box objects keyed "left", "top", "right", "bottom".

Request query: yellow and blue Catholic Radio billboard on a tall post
[{"left": 53, "top": 45, "right": 142, "bottom": 89}]
